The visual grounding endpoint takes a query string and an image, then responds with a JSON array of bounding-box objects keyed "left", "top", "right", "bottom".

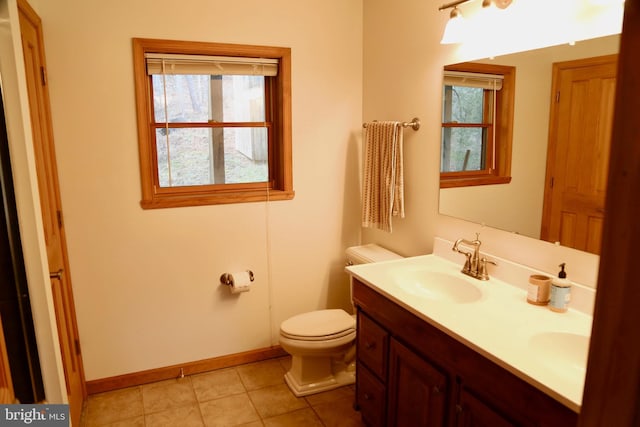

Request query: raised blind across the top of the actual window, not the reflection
[{"left": 144, "top": 53, "right": 278, "bottom": 76}]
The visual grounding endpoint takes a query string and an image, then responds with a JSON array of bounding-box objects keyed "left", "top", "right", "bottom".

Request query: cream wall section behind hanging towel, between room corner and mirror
[{"left": 363, "top": 0, "right": 446, "bottom": 255}]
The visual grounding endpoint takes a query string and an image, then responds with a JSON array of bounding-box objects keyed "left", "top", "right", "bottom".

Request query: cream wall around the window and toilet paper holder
[{"left": 31, "top": 0, "right": 363, "bottom": 380}]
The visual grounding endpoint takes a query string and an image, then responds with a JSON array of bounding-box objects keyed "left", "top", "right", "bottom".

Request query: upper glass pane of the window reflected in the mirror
[{"left": 442, "top": 86, "right": 484, "bottom": 123}]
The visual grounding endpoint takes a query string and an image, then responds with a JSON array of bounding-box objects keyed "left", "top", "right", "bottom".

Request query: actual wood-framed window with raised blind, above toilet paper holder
[{"left": 133, "top": 38, "right": 294, "bottom": 209}]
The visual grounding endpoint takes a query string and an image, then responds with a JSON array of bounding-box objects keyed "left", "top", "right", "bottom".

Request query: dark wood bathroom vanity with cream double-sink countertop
[{"left": 348, "top": 249, "right": 591, "bottom": 427}]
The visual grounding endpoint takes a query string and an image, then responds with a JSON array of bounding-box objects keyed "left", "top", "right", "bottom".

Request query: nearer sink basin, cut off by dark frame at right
[{"left": 529, "top": 332, "right": 589, "bottom": 378}]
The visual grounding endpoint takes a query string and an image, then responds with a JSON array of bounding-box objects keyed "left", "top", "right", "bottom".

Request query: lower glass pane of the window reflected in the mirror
[{"left": 440, "top": 128, "right": 487, "bottom": 172}]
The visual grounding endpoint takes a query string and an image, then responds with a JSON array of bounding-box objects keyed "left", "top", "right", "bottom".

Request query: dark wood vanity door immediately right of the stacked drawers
[{"left": 387, "top": 338, "right": 448, "bottom": 427}]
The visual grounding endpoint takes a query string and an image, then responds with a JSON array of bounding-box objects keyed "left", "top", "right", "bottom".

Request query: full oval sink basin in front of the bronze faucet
[{"left": 396, "top": 270, "right": 482, "bottom": 304}]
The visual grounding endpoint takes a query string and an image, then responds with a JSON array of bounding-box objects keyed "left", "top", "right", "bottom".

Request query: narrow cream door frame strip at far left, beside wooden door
[{"left": 0, "top": 0, "right": 67, "bottom": 402}]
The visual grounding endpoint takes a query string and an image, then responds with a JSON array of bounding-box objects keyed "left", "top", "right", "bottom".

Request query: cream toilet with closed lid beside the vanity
[{"left": 280, "top": 244, "right": 402, "bottom": 397}]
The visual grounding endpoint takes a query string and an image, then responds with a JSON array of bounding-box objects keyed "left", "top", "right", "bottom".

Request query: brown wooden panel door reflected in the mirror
[{"left": 541, "top": 55, "right": 617, "bottom": 254}]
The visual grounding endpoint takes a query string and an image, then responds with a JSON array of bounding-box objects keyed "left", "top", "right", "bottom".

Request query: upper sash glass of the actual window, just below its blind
[{"left": 152, "top": 74, "right": 265, "bottom": 123}]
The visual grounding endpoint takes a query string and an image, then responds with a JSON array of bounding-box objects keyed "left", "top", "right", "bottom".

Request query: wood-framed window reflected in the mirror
[{"left": 440, "top": 63, "right": 515, "bottom": 188}]
